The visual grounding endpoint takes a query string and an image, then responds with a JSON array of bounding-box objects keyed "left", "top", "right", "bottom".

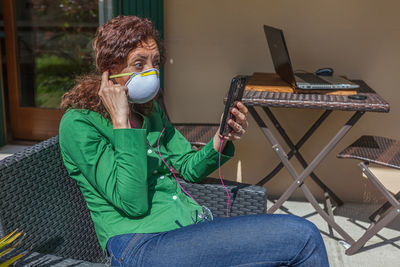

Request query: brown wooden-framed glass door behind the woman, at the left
[{"left": 2, "top": 0, "right": 101, "bottom": 140}]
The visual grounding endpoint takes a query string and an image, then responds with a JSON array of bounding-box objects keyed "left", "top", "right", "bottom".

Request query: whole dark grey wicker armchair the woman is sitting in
[{"left": 0, "top": 136, "right": 266, "bottom": 266}]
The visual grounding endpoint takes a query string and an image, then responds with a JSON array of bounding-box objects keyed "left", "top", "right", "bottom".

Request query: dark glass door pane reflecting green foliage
[{"left": 15, "top": 0, "right": 99, "bottom": 108}]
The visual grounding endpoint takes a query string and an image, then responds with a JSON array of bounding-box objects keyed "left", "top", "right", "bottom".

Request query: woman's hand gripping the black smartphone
[{"left": 213, "top": 102, "right": 249, "bottom": 151}]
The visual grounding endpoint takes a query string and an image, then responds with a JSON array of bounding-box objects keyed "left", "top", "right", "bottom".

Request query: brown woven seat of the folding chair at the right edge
[{"left": 337, "top": 135, "right": 400, "bottom": 169}]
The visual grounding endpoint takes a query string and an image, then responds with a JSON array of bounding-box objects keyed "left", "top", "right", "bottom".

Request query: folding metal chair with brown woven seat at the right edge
[{"left": 337, "top": 136, "right": 400, "bottom": 255}]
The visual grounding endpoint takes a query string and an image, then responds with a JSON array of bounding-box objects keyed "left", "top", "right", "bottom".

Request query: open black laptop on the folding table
[{"left": 264, "top": 25, "right": 360, "bottom": 90}]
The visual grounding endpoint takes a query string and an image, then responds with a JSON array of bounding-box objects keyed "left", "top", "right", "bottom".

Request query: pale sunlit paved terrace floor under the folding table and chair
[{"left": 0, "top": 145, "right": 400, "bottom": 267}]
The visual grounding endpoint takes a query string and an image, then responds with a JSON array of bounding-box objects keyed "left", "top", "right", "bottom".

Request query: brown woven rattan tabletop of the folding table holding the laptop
[{"left": 242, "top": 80, "right": 389, "bottom": 112}]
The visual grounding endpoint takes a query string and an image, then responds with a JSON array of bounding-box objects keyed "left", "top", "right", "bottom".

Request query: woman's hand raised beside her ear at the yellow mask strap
[{"left": 99, "top": 71, "right": 131, "bottom": 129}]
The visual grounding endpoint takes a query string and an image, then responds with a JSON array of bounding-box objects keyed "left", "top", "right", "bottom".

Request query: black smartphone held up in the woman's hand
[{"left": 219, "top": 75, "right": 248, "bottom": 135}]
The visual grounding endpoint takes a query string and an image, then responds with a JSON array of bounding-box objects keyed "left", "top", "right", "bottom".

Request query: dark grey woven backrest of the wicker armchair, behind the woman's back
[{"left": 0, "top": 137, "right": 105, "bottom": 262}]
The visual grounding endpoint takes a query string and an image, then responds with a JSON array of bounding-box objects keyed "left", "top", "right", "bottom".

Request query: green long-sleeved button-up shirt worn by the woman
[{"left": 59, "top": 104, "right": 234, "bottom": 249}]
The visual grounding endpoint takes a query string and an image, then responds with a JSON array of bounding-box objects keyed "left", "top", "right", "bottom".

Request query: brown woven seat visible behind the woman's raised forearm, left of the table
[{"left": 174, "top": 123, "right": 219, "bottom": 146}]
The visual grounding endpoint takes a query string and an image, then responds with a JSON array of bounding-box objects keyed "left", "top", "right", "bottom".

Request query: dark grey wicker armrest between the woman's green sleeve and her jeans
[{"left": 180, "top": 178, "right": 267, "bottom": 217}]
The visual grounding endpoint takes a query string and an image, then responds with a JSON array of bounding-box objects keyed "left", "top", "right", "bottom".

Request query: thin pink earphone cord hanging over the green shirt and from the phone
[{"left": 129, "top": 119, "right": 230, "bottom": 217}]
